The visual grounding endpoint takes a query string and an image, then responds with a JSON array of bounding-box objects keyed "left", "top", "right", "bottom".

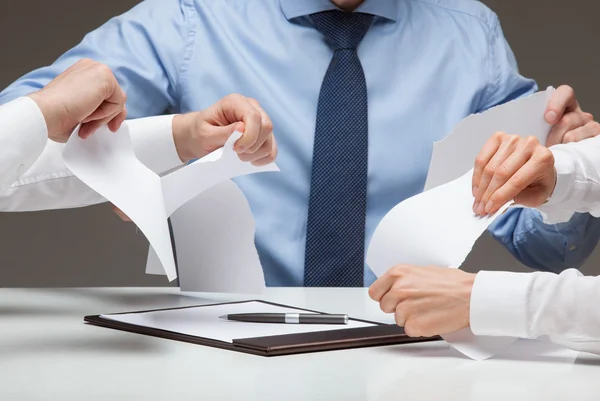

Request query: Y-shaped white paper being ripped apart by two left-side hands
[{"left": 63, "top": 122, "right": 278, "bottom": 288}]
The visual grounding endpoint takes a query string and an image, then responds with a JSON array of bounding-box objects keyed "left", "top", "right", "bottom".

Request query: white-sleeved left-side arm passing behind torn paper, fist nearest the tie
[{"left": 0, "top": 95, "right": 277, "bottom": 211}]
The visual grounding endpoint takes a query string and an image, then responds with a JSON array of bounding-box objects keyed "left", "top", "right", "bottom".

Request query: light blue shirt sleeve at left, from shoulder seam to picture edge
[{"left": 0, "top": 0, "right": 194, "bottom": 119}]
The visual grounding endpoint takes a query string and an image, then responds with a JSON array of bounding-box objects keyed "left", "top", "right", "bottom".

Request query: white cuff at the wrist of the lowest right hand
[{"left": 470, "top": 271, "right": 533, "bottom": 338}]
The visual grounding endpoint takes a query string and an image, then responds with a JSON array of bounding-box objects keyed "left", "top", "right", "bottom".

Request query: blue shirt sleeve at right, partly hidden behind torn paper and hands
[{"left": 479, "top": 15, "right": 600, "bottom": 273}]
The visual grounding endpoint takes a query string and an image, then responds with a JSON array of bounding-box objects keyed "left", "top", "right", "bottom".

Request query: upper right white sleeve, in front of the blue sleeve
[{"left": 538, "top": 136, "right": 600, "bottom": 224}]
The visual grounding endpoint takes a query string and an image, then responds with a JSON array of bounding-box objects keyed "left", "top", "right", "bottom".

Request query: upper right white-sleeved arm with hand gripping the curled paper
[{"left": 473, "top": 133, "right": 600, "bottom": 223}]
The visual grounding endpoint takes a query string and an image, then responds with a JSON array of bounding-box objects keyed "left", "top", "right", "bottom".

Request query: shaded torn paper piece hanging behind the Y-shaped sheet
[{"left": 171, "top": 180, "right": 265, "bottom": 294}]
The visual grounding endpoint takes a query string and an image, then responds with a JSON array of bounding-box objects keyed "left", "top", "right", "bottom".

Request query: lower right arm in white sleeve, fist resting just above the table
[{"left": 369, "top": 265, "right": 600, "bottom": 354}]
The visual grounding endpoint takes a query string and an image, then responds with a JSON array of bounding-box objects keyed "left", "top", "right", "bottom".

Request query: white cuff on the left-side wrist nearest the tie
[{"left": 127, "top": 115, "right": 183, "bottom": 174}]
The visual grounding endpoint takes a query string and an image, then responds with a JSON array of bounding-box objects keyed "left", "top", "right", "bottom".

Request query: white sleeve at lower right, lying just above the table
[{"left": 470, "top": 269, "right": 600, "bottom": 354}]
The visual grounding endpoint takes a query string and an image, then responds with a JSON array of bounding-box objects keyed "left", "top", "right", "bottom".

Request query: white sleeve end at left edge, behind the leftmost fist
[{"left": 0, "top": 97, "right": 48, "bottom": 191}]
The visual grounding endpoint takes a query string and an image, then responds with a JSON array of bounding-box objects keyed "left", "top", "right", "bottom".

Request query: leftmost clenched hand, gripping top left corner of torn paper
[{"left": 29, "top": 59, "right": 127, "bottom": 142}]
